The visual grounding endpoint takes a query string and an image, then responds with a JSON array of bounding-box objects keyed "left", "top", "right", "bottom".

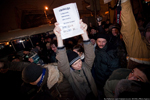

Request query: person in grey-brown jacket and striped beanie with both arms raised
[{"left": 54, "top": 20, "right": 98, "bottom": 100}]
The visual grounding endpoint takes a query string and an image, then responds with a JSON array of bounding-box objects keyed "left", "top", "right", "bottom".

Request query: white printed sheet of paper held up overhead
[{"left": 53, "top": 3, "right": 83, "bottom": 39}]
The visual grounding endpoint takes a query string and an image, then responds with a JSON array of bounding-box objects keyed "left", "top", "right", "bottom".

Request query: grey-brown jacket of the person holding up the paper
[{"left": 56, "top": 42, "right": 97, "bottom": 100}]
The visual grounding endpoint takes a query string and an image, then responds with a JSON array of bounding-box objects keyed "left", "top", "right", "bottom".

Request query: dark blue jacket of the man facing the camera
[{"left": 94, "top": 44, "right": 119, "bottom": 89}]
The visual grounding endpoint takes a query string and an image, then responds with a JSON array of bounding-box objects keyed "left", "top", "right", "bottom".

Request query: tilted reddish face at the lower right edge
[{"left": 128, "top": 68, "right": 148, "bottom": 82}]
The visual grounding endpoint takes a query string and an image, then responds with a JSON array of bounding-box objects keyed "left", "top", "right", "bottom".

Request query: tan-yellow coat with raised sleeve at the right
[{"left": 121, "top": 0, "right": 150, "bottom": 66}]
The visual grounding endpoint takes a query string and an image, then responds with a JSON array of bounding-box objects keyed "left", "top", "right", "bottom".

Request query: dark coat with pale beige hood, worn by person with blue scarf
[{"left": 40, "top": 63, "right": 76, "bottom": 100}]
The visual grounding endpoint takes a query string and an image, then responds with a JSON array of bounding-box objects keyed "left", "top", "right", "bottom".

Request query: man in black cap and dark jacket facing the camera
[{"left": 94, "top": 34, "right": 119, "bottom": 98}]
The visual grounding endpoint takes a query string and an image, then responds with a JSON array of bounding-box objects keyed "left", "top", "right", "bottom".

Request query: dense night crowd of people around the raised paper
[{"left": 0, "top": 0, "right": 150, "bottom": 100}]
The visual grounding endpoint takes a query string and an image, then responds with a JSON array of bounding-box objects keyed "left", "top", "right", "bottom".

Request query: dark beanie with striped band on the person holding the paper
[{"left": 67, "top": 51, "right": 80, "bottom": 66}]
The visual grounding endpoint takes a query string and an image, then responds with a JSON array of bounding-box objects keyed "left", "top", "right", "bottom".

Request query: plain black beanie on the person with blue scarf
[{"left": 22, "top": 63, "right": 43, "bottom": 83}]
